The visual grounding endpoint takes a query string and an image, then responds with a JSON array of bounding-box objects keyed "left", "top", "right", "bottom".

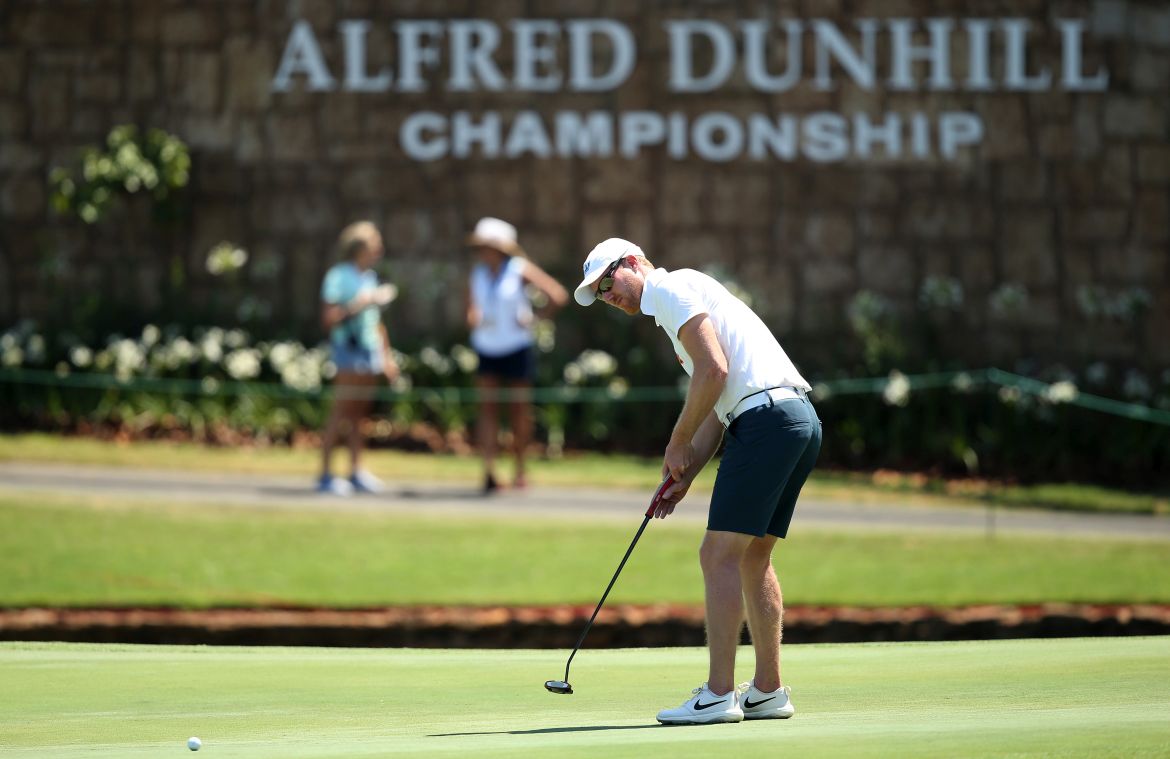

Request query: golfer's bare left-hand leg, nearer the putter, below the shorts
[{"left": 698, "top": 530, "right": 752, "bottom": 696}]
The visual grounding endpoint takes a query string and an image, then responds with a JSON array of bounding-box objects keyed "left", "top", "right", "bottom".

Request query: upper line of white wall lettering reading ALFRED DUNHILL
[{"left": 271, "top": 18, "right": 1109, "bottom": 92}]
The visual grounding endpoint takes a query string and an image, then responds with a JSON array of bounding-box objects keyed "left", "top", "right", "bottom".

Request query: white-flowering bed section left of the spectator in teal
[{"left": 0, "top": 322, "right": 339, "bottom": 440}]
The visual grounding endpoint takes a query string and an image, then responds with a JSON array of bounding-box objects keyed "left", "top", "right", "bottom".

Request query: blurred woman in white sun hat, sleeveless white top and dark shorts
[{"left": 467, "top": 216, "right": 569, "bottom": 495}]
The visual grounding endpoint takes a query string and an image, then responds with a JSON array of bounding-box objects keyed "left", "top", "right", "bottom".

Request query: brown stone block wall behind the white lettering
[{"left": 0, "top": 0, "right": 1170, "bottom": 366}]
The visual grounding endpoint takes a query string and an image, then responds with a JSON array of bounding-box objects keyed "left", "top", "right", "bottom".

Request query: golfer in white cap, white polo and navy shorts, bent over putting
[{"left": 573, "top": 237, "right": 821, "bottom": 724}]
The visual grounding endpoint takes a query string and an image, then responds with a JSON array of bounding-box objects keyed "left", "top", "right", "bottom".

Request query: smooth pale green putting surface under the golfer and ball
[{"left": 0, "top": 637, "right": 1170, "bottom": 759}]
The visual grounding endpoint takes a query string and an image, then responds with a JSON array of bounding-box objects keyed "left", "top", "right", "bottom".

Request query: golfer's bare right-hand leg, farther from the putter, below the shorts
[{"left": 739, "top": 534, "right": 784, "bottom": 692}]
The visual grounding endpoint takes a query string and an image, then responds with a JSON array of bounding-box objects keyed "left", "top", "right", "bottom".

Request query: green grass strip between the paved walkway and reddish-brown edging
[{"left": 0, "top": 494, "right": 1170, "bottom": 608}]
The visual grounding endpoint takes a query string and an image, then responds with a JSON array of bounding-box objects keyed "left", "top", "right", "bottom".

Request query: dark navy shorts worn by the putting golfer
[{"left": 707, "top": 394, "right": 821, "bottom": 538}]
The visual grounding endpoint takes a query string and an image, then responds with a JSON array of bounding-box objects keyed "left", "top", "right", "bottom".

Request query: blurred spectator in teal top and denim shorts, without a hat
[{"left": 317, "top": 221, "right": 398, "bottom": 496}]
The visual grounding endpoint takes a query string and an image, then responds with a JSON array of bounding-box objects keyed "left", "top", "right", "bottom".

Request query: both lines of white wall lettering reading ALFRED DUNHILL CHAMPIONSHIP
[{"left": 271, "top": 18, "right": 1109, "bottom": 163}]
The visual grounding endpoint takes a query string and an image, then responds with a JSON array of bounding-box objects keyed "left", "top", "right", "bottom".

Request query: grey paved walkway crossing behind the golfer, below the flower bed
[{"left": 0, "top": 462, "right": 1170, "bottom": 541}]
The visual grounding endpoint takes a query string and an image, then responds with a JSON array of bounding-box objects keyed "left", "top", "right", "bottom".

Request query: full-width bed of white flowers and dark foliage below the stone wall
[{"left": 0, "top": 315, "right": 1170, "bottom": 484}]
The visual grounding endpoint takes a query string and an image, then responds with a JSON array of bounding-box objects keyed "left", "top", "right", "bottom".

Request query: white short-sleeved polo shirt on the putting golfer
[{"left": 641, "top": 268, "right": 812, "bottom": 420}]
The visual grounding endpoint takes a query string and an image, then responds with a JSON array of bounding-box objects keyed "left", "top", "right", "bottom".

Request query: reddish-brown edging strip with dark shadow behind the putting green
[{"left": 0, "top": 603, "right": 1170, "bottom": 648}]
